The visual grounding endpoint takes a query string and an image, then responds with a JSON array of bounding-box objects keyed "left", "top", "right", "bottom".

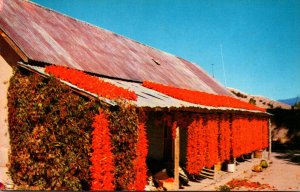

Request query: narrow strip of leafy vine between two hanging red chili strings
[{"left": 107, "top": 102, "right": 138, "bottom": 190}]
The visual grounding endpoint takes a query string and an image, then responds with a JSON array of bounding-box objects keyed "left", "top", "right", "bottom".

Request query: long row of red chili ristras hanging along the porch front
[{"left": 186, "top": 114, "right": 268, "bottom": 174}]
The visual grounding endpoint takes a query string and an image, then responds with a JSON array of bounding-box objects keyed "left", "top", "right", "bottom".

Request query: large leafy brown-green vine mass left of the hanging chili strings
[{"left": 8, "top": 71, "right": 100, "bottom": 190}]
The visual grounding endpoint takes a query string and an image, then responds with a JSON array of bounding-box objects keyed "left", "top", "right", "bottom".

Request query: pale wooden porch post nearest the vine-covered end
[{"left": 174, "top": 127, "right": 180, "bottom": 190}]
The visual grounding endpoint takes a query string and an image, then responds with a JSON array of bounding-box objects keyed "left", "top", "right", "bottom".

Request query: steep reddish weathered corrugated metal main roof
[{"left": 0, "top": 0, "right": 232, "bottom": 96}]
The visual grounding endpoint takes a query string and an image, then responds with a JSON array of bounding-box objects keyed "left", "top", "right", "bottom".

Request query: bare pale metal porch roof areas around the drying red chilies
[{"left": 19, "top": 63, "right": 262, "bottom": 113}]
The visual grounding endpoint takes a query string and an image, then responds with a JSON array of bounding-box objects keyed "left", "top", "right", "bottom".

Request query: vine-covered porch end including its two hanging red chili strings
[{"left": 8, "top": 70, "right": 147, "bottom": 190}]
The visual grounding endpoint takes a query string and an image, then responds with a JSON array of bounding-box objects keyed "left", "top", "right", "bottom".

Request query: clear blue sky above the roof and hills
[{"left": 33, "top": 0, "right": 300, "bottom": 99}]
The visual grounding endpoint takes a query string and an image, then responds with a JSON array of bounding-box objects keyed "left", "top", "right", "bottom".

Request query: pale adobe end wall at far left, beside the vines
[{"left": 0, "top": 36, "right": 20, "bottom": 184}]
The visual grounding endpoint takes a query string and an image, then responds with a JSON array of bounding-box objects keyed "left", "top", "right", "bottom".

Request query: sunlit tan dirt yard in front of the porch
[{"left": 181, "top": 150, "right": 300, "bottom": 191}]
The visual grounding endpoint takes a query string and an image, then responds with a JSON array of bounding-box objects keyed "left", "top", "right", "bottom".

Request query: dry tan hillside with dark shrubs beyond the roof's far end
[{"left": 227, "top": 87, "right": 291, "bottom": 109}]
